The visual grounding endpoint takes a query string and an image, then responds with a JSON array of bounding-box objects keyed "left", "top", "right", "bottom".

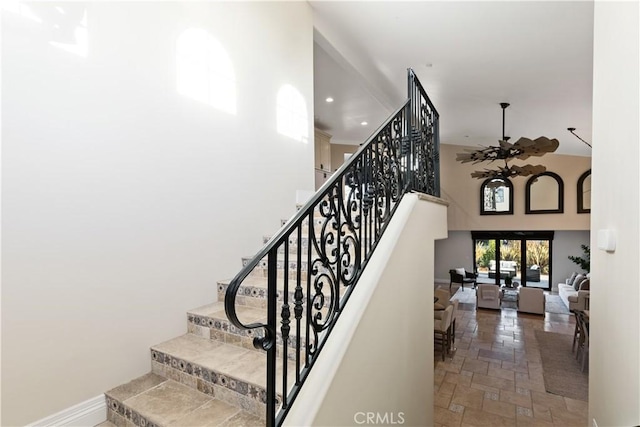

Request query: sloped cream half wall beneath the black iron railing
[{"left": 285, "top": 194, "right": 447, "bottom": 427}]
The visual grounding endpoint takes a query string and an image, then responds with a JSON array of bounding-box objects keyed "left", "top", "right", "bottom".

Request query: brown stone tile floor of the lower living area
[{"left": 434, "top": 289, "right": 588, "bottom": 427}]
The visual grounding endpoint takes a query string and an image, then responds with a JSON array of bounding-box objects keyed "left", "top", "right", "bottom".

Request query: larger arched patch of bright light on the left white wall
[{"left": 176, "top": 28, "right": 236, "bottom": 114}]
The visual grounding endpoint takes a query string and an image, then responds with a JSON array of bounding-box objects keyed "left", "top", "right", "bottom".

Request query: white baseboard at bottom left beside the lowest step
[{"left": 27, "top": 394, "right": 107, "bottom": 427}]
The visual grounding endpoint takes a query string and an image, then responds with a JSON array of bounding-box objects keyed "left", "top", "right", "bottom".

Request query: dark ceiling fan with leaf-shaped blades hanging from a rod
[{"left": 456, "top": 102, "right": 560, "bottom": 178}]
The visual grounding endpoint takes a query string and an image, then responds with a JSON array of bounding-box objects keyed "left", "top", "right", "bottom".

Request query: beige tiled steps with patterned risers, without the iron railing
[{"left": 105, "top": 216, "right": 307, "bottom": 427}]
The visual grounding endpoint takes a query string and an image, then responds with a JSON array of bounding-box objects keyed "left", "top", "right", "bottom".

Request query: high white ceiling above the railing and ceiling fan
[{"left": 309, "top": 0, "right": 597, "bottom": 156}]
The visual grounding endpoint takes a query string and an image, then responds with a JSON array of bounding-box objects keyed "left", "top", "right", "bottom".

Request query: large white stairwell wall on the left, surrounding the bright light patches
[{"left": 2, "top": 2, "right": 313, "bottom": 426}]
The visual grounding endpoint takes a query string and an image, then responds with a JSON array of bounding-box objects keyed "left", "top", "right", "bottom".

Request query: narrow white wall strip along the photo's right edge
[{"left": 589, "top": 1, "right": 640, "bottom": 426}]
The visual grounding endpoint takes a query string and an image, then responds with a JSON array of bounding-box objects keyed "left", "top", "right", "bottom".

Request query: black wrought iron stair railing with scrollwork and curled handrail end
[{"left": 225, "top": 70, "right": 440, "bottom": 426}]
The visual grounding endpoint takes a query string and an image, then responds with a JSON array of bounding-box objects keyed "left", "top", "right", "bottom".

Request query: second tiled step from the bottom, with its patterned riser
[{"left": 151, "top": 334, "right": 295, "bottom": 417}]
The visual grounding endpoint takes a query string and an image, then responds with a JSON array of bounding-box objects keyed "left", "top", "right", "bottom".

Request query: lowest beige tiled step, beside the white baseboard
[{"left": 105, "top": 373, "right": 264, "bottom": 427}]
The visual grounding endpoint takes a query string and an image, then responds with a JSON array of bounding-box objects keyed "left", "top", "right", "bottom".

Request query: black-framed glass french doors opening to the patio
[{"left": 471, "top": 231, "right": 553, "bottom": 290}]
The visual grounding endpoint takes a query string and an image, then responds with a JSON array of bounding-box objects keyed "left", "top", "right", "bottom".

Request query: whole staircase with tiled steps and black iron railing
[{"left": 105, "top": 70, "right": 439, "bottom": 427}]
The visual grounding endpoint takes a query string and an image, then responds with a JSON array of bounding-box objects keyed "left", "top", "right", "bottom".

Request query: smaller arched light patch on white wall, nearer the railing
[{"left": 276, "top": 84, "right": 309, "bottom": 143}]
